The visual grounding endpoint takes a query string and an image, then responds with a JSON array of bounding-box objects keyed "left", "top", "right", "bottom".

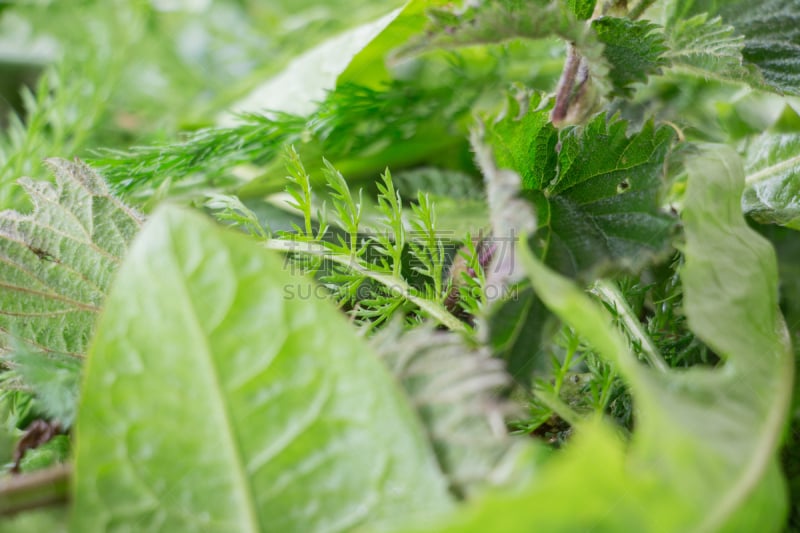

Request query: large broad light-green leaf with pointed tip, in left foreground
[{"left": 72, "top": 208, "right": 449, "bottom": 533}]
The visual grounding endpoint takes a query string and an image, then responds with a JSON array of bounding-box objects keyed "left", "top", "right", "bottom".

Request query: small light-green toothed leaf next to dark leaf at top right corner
[{"left": 666, "top": 13, "right": 751, "bottom": 80}]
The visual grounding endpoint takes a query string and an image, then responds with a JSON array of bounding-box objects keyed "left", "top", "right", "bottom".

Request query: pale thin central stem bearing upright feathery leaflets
[{"left": 264, "top": 239, "right": 468, "bottom": 332}]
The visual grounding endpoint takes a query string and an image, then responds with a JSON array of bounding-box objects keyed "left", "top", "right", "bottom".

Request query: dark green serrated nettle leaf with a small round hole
[{"left": 487, "top": 95, "right": 674, "bottom": 275}]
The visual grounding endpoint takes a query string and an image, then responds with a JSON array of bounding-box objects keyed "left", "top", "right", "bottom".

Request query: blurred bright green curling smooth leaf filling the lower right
[{"left": 400, "top": 146, "right": 793, "bottom": 533}]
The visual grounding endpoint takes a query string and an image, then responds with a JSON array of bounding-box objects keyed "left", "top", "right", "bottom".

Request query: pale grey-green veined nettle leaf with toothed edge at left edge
[{"left": 0, "top": 159, "right": 142, "bottom": 357}]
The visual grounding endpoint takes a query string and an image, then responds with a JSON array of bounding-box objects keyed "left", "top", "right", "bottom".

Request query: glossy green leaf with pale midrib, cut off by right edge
[{"left": 742, "top": 133, "right": 800, "bottom": 230}]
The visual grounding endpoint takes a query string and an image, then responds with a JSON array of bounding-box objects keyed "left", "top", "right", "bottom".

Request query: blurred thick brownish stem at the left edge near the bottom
[{"left": 0, "top": 464, "right": 71, "bottom": 516}]
